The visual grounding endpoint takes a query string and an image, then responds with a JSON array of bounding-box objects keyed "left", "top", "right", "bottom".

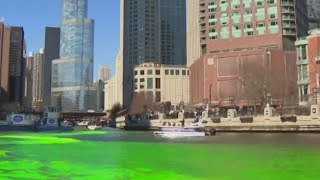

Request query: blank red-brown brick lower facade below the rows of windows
[{"left": 190, "top": 49, "right": 297, "bottom": 106}]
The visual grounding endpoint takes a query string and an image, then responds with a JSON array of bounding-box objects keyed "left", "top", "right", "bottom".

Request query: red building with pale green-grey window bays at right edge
[{"left": 295, "top": 29, "right": 320, "bottom": 105}]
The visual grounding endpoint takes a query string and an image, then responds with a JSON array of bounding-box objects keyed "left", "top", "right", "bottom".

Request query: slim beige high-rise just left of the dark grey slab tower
[{"left": 32, "top": 49, "right": 45, "bottom": 111}]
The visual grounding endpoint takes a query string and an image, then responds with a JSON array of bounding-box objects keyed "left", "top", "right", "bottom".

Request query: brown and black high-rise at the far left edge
[{"left": 0, "top": 27, "right": 25, "bottom": 105}]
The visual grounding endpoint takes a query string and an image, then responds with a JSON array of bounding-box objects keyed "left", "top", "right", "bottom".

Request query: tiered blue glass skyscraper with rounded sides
[{"left": 51, "top": 0, "right": 96, "bottom": 111}]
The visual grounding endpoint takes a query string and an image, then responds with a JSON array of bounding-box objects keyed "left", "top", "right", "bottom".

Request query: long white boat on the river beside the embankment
[{"left": 154, "top": 131, "right": 206, "bottom": 138}]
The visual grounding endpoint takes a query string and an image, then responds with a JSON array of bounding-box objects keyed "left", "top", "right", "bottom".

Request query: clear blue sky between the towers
[{"left": 0, "top": 0, "right": 120, "bottom": 79}]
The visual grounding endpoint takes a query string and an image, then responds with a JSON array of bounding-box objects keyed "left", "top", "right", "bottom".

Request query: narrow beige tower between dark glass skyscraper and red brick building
[{"left": 187, "top": 0, "right": 201, "bottom": 67}]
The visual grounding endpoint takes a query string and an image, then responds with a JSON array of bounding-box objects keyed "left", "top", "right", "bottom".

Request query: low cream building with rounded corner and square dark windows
[{"left": 134, "top": 63, "right": 190, "bottom": 106}]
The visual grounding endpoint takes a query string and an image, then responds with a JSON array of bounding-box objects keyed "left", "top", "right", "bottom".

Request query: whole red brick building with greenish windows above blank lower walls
[{"left": 190, "top": 0, "right": 297, "bottom": 106}]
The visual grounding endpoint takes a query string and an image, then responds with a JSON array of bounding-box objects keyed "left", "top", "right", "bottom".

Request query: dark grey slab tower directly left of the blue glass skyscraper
[{"left": 43, "top": 27, "right": 60, "bottom": 107}]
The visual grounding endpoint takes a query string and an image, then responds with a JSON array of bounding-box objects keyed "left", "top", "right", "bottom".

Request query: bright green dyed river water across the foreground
[{"left": 0, "top": 132, "right": 320, "bottom": 180}]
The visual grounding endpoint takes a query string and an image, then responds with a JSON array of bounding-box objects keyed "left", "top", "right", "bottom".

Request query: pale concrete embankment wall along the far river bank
[{"left": 117, "top": 116, "right": 320, "bottom": 132}]
